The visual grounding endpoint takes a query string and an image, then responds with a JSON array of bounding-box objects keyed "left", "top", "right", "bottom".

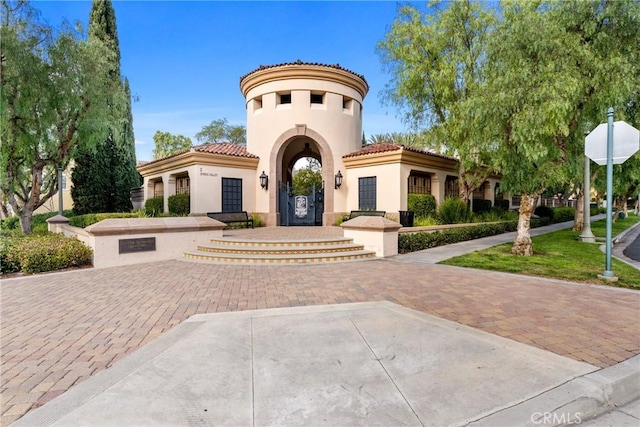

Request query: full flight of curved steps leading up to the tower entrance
[{"left": 184, "top": 238, "right": 375, "bottom": 264}]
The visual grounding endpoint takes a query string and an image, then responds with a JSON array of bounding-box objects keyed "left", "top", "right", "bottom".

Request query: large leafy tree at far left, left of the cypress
[{"left": 0, "top": 0, "right": 112, "bottom": 233}]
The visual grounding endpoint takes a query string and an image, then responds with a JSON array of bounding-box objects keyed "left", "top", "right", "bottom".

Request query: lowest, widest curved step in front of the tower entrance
[{"left": 184, "top": 250, "right": 375, "bottom": 265}]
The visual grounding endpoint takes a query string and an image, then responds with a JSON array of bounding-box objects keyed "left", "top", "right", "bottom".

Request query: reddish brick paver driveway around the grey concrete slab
[{"left": 0, "top": 260, "right": 640, "bottom": 425}]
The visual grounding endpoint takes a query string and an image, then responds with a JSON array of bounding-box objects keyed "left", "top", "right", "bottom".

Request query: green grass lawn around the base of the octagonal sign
[{"left": 442, "top": 215, "right": 640, "bottom": 289}]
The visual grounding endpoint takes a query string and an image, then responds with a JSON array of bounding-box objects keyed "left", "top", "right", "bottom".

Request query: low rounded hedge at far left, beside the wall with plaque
[{"left": 0, "top": 234, "right": 93, "bottom": 274}]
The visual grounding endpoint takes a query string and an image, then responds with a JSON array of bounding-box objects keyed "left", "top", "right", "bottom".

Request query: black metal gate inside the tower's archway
[{"left": 278, "top": 183, "right": 324, "bottom": 226}]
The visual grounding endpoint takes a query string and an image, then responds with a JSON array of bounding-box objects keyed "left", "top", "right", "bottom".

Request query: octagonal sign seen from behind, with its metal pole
[{"left": 584, "top": 108, "right": 640, "bottom": 282}]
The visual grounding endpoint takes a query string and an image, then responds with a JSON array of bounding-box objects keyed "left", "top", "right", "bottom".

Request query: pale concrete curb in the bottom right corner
[{"left": 467, "top": 355, "right": 640, "bottom": 427}]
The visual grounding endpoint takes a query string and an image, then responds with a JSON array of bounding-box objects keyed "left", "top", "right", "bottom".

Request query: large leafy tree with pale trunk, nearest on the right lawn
[{"left": 476, "top": 0, "right": 640, "bottom": 255}]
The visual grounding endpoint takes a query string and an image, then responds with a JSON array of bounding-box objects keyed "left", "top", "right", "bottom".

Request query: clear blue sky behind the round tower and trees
[{"left": 33, "top": 1, "right": 424, "bottom": 161}]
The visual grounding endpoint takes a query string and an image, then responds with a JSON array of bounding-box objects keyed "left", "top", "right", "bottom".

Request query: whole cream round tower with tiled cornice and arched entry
[{"left": 240, "top": 61, "right": 369, "bottom": 225}]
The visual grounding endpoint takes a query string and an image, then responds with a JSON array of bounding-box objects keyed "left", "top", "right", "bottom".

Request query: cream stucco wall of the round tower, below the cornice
[{"left": 246, "top": 70, "right": 363, "bottom": 225}]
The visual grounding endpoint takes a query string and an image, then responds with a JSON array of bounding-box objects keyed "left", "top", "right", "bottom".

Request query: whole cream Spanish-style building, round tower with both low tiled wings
[{"left": 138, "top": 61, "right": 499, "bottom": 226}]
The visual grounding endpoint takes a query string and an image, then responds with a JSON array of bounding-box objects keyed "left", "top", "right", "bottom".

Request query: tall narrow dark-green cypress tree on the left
[{"left": 71, "top": 0, "right": 140, "bottom": 214}]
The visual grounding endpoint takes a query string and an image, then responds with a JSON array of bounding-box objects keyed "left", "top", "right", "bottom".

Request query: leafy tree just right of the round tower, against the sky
[{"left": 378, "top": 0, "right": 495, "bottom": 202}]
